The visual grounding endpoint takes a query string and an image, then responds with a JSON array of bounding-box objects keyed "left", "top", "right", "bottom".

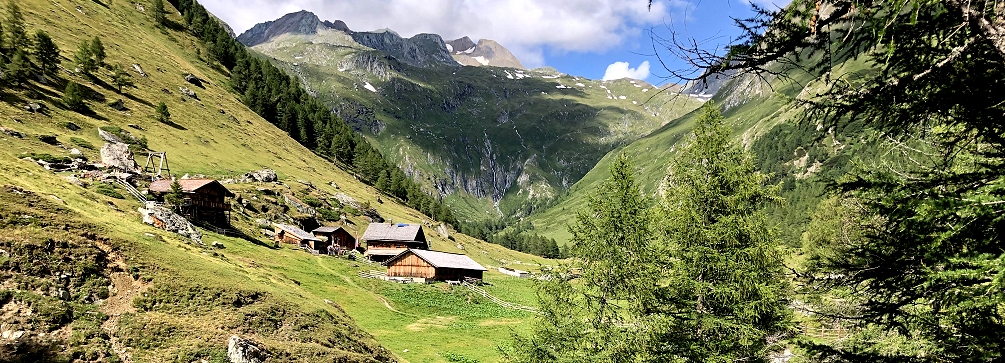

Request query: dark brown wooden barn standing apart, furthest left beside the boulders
[{"left": 147, "top": 179, "right": 234, "bottom": 224}]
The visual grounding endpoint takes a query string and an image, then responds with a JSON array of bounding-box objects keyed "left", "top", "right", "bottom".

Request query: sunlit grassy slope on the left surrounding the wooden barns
[{"left": 0, "top": 0, "right": 548, "bottom": 362}]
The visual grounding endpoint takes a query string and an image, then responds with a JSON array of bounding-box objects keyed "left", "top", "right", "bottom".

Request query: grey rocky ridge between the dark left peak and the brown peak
[{"left": 351, "top": 30, "right": 457, "bottom": 66}]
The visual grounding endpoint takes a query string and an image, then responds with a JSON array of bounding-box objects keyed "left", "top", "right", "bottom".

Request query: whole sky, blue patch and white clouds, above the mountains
[{"left": 200, "top": 0, "right": 789, "bottom": 83}]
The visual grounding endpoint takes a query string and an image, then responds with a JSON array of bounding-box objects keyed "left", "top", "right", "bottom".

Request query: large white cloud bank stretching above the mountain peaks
[{"left": 201, "top": 0, "right": 680, "bottom": 66}]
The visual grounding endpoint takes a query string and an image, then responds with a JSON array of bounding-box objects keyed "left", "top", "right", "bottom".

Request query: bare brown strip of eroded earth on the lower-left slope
[{"left": 95, "top": 241, "right": 150, "bottom": 363}]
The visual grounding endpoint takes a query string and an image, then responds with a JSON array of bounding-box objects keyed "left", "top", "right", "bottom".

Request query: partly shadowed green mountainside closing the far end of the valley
[{"left": 248, "top": 30, "right": 698, "bottom": 220}]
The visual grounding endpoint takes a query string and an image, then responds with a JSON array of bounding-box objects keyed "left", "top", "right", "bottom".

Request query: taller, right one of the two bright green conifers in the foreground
[{"left": 643, "top": 102, "right": 792, "bottom": 363}]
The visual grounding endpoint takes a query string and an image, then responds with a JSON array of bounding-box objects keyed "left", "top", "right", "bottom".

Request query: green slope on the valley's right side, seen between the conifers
[{"left": 528, "top": 53, "right": 874, "bottom": 245}]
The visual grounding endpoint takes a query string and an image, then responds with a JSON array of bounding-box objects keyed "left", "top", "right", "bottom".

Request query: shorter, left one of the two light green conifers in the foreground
[{"left": 508, "top": 150, "right": 664, "bottom": 363}]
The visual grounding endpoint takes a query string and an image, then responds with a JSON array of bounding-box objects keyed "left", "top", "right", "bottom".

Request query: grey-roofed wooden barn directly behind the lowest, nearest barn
[{"left": 362, "top": 223, "right": 429, "bottom": 261}]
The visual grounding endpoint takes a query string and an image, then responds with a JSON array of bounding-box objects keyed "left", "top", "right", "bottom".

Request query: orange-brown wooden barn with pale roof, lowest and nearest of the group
[{"left": 384, "top": 249, "right": 485, "bottom": 281}]
